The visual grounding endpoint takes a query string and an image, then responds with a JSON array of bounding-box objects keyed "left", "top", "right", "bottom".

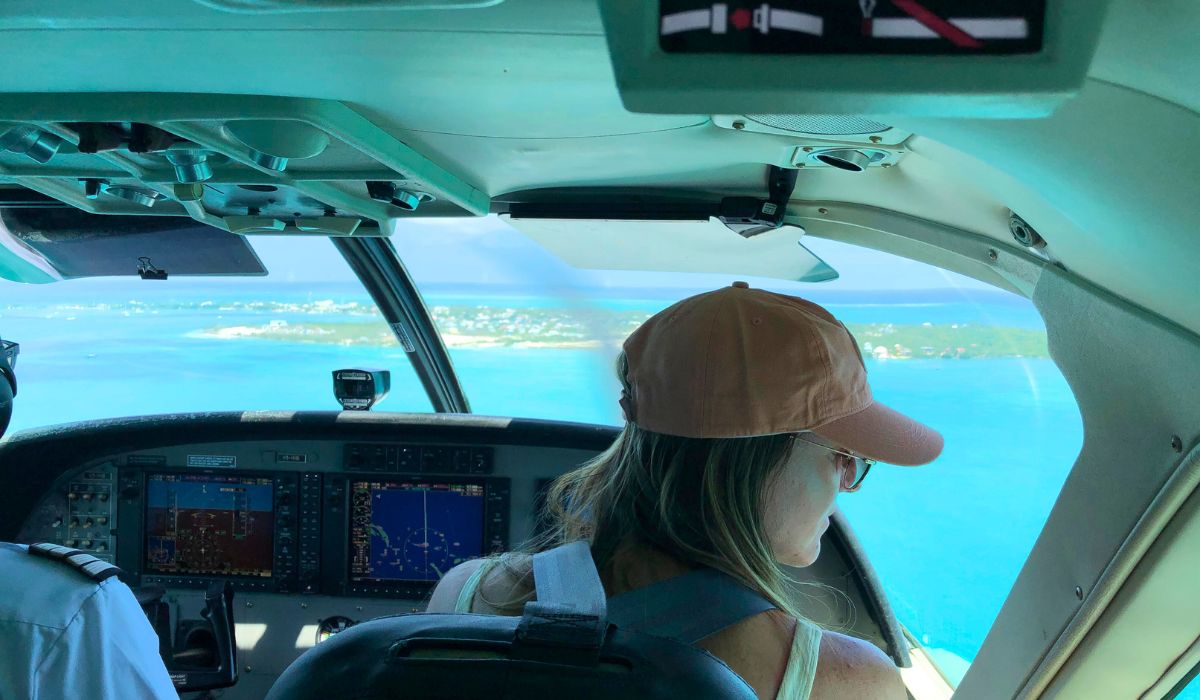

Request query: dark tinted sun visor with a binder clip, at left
[{"left": 0, "top": 207, "right": 266, "bottom": 282}]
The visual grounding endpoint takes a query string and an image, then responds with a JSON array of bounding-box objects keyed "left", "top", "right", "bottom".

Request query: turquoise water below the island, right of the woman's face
[{"left": 841, "top": 359, "right": 1082, "bottom": 671}]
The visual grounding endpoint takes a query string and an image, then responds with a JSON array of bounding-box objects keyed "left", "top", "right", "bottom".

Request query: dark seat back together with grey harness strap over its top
[{"left": 268, "top": 542, "right": 769, "bottom": 700}]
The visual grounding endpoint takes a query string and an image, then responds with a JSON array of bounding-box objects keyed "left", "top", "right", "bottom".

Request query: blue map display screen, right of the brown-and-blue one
[{"left": 350, "top": 480, "right": 485, "bottom": 581}]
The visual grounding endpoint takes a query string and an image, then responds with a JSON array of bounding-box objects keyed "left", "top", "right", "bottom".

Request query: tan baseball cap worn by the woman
[{"left": 620, "top": 282, "right": 942, "bottom": 466}]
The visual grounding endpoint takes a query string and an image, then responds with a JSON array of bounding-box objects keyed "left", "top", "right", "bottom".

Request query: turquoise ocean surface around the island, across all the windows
[{"left": 0, "top": 282, "right": 1082, "bottom": 678}]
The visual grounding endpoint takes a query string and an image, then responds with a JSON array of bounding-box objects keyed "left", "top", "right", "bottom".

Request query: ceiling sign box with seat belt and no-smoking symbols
[{"left": 600, "top": 0, "right": 1108, "bottom": 119}]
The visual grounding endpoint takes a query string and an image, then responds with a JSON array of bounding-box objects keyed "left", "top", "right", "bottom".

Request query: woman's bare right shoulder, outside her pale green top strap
[{"left": 812, "top": 630, "right": 908, "bottom": 700}]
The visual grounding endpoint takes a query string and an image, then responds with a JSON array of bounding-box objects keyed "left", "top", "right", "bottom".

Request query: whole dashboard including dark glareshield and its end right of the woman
[{"left": 0, "top": 412, "right": 906, "bottom": 700}]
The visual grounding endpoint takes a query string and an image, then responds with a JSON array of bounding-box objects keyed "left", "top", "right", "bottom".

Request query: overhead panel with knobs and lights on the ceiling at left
[{"left": 0, "top": 94, "right": 490, "bottom": 237}]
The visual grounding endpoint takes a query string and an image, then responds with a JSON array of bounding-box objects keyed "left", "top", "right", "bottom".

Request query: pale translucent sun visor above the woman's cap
[{"left": 500, "top": 214, "right": 838, "bottom": 282}]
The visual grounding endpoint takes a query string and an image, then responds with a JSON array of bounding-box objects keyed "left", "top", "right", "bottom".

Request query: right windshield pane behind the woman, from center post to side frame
[{"left": 394, "top": 217, "right": 1082, "bottom": 683}]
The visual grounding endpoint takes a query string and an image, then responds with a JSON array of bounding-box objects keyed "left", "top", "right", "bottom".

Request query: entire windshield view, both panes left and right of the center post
[{"left": 0, "top": 217, "right": 1082, "bottom": 682}]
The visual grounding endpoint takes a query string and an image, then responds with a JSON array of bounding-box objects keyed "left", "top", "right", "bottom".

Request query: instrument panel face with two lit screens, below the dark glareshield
[{"left": 0, "top": 420, "right": 595, "bottom": 699}]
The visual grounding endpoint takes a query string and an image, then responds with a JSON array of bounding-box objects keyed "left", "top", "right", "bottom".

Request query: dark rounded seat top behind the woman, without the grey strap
[{"left": 266, "top": 614, "right": 756, "bottom": 700}]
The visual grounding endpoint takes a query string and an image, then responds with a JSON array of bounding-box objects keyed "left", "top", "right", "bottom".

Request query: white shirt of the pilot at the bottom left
[{"left": 0, "top": 543, "right": 179, "bottom": 700}]
